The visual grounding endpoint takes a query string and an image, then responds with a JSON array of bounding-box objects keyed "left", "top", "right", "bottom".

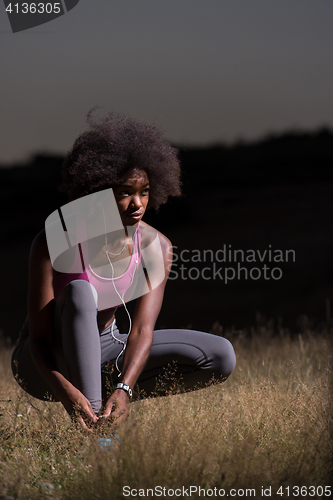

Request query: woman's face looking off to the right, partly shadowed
[{"left": 113, "top": 168, "right": 149, "bottom": 226}]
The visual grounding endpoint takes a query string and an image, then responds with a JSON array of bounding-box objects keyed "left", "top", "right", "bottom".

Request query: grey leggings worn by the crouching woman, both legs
[{"left": 12, "top": 280, "right": 236, "bottom": 413}]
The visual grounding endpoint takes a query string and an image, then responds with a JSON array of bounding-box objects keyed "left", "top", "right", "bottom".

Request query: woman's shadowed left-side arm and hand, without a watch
[{"left": 28, "top": 231, "right": 97, "bottom": 427}]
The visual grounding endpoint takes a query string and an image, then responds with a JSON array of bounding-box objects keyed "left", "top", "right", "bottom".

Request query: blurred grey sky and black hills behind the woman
[{"left": 0, "top": 0, "right": 333, "bottom": 341}]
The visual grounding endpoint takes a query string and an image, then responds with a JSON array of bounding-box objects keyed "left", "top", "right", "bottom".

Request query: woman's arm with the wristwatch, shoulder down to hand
[{"left": 105, "top": 230, "right": 172, "bottom": 422}]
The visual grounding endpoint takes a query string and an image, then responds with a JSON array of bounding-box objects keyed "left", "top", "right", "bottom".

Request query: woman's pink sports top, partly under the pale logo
[{"left": 53, "top": 223, "right": 141, "bottom": 311}]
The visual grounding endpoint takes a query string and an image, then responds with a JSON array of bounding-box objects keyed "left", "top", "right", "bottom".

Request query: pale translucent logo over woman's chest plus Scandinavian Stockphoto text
[{"left": 45, "top": 188, "right": 296, "bottom": 294}]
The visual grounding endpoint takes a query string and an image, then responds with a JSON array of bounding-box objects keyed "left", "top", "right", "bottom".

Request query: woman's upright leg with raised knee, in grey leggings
[{"left": 12, "top": 280, "right": 102, "bottom": 413}]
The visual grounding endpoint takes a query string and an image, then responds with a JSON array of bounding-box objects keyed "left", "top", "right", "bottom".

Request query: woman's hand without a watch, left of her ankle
[{"left": 57, "top": 383, "right": 98, "bottom": 432}]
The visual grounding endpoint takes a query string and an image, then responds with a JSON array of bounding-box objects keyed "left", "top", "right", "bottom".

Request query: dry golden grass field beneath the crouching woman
[{"left": 0, "top": 325, "right": 333, "bottom": 500}]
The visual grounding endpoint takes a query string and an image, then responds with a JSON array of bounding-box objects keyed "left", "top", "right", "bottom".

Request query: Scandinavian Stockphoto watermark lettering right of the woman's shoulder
[{"left": 169, "top": 244, "right": 296, "bottom": 284}]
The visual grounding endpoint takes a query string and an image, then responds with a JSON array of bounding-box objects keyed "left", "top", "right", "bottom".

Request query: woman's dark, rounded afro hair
[{"left": 59, "top": 108, "right": 181, "bottom": 210}]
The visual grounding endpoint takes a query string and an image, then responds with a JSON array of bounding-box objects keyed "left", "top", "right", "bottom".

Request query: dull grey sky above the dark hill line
[{"left": 0, "top": 0, "right": 333, "bottom": 164}]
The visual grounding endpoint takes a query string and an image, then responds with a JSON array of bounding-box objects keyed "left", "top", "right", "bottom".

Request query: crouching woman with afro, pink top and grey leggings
[{"left": 12, "top": 113, "right": 235, "bottom": 428}]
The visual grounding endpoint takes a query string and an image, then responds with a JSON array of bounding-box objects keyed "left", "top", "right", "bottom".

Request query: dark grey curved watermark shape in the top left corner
[{"left": 4, "top": 0, "right": 79, "bottom": 33}]
